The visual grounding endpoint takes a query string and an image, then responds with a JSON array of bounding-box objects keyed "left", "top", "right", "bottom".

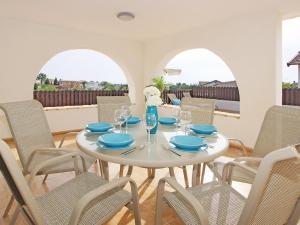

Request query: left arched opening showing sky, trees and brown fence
[{"left": 33, "top": 49, "right": 128, "bottom": 107}]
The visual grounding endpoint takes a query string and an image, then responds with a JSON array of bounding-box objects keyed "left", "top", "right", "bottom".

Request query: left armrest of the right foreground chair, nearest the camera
[{"left": 156, "top": 177, "right": 209, "bottom": 225}]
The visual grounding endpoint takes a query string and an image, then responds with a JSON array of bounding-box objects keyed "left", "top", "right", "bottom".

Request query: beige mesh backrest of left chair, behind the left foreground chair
[{"left": 0, "top": 100, "right": 55, "bottom": 171}]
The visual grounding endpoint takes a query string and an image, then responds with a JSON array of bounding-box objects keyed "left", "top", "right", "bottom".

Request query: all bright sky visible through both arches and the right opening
[{"left": 40, "top": 17, "right": 300, "bottom": 84}]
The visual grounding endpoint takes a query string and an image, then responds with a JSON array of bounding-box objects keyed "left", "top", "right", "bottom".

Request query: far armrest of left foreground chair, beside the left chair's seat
[{"left": 30, "top": 151, "right": 87, "bottom": 182}]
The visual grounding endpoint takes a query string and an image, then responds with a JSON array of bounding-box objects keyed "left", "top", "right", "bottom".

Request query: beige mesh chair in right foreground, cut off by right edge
[{"left": 156, "top": 147, "right": 300, "bottom": 225}]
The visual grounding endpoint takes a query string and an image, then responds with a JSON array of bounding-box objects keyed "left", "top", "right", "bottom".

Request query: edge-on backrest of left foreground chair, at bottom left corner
[{"left": 0, "top": 140, "right": 45, "bottom": 225}]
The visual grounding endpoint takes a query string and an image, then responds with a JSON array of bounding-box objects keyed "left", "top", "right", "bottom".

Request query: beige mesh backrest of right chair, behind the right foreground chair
[{"left": 253, "top": 106, "right": 300, "bottom": 157}]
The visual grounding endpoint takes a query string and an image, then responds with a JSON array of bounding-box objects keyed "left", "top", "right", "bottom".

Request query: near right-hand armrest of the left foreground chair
[{"left": 69, "top": 177, "right": 138, "bottom": 225}]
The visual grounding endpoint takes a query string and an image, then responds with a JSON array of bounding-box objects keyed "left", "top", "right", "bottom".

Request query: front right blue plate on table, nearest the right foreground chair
[{"left": 170, "top": 135, "right": 207, "bottom": 151}]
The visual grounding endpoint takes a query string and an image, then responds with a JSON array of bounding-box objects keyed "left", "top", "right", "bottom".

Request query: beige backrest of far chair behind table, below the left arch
[{"left": 97, "top": 96, "right": 131, "bottom": 122}]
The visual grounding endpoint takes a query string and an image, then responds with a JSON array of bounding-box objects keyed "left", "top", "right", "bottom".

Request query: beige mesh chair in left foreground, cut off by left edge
[{"left": 0, "top": 140, "right": 141, "bottom": 225}]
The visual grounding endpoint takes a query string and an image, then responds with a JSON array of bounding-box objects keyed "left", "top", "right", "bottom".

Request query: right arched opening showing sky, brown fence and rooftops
[{"left": 164, "top": 48, "right": 240, "bottom": 112}]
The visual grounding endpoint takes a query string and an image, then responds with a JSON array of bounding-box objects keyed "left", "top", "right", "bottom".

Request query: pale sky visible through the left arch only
[{"left": 40, "top": 49, "right": 127, "bottom": 84}]
